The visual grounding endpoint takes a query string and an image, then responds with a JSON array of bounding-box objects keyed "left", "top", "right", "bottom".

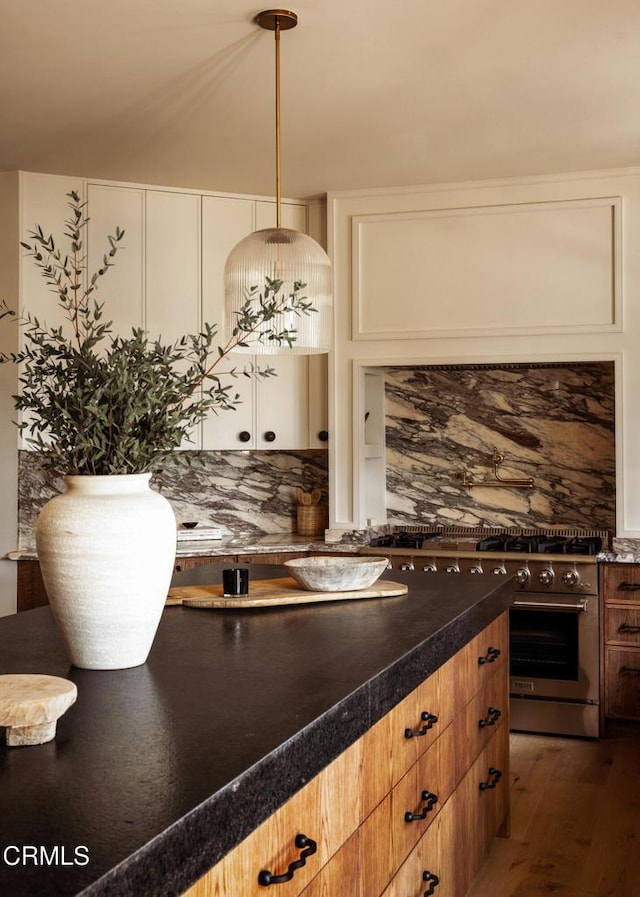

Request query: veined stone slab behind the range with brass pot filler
[{"left": 385, "top": 362, "right": 615, "bottom": 532}]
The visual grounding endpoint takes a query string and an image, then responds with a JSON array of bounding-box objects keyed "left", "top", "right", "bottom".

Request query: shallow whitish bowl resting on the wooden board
[{"left": 284, "top": 557, "right": 388, "bottom": 592}]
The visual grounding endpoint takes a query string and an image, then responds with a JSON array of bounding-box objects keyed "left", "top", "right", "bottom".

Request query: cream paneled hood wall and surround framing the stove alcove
[{"left": 328, "top": 169, "right": 640, "bottom": 537}]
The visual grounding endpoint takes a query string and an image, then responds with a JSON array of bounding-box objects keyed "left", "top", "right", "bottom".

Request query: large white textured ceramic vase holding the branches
[{"left": 36, "top": 473, "right": 176, "bottom": 670}]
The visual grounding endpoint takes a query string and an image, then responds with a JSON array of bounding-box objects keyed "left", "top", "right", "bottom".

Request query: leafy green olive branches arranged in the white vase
[{"left": 0, "top": 191, "right": 315, "bottom": 475}]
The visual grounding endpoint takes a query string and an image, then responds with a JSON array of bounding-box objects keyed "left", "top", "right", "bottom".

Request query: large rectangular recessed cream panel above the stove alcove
[{"left": 352, "top": 197, "right": 620, "bottom": 339}]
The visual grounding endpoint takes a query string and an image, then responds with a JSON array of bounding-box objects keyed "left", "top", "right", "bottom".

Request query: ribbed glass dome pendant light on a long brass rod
[{"left": 224, "top": 9, "right": 333, "bottom": 355}]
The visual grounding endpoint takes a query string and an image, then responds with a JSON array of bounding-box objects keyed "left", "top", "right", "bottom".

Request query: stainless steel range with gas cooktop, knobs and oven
[{"left": 368, "top": 527, "right": 610, "bottom": 738}]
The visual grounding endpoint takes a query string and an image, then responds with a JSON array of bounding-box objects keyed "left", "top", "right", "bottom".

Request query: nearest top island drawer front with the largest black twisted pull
[{"left": 184, "top": 741, "right": 362, "bottom": 897}]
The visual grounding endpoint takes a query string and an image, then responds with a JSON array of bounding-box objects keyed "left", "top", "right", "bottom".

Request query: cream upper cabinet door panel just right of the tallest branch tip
[{"left": 87, "top": 184, "right": 144, "bottom": 336}]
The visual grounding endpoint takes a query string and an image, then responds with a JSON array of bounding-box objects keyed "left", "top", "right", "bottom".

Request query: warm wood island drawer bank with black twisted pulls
[{"left": 184, "top": 613, "right": 509, "bottom": 897}]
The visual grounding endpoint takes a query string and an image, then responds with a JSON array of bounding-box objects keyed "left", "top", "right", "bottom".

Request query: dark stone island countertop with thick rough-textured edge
[{"left": 0, "top": 566, "right": 512, "bottom": 897}]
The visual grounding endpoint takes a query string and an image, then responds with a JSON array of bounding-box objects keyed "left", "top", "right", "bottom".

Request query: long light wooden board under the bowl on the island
[{"left": 167, "top": 576, "right": 408, "bottom": 608}]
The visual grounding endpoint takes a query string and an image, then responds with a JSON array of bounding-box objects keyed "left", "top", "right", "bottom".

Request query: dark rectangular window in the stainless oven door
[{"left": 509, "top": 608, "right": 579, "bottom": 680}]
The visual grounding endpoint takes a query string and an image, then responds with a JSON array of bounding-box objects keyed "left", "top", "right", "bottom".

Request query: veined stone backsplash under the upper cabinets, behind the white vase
[{"left": 18, "top": 449, "right": 328, "bottom": 549}]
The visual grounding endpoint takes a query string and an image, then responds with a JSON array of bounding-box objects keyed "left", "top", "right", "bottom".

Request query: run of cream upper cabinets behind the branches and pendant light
[{"left": 15, "top": 173, "right": 326, "bottom": 450}]
